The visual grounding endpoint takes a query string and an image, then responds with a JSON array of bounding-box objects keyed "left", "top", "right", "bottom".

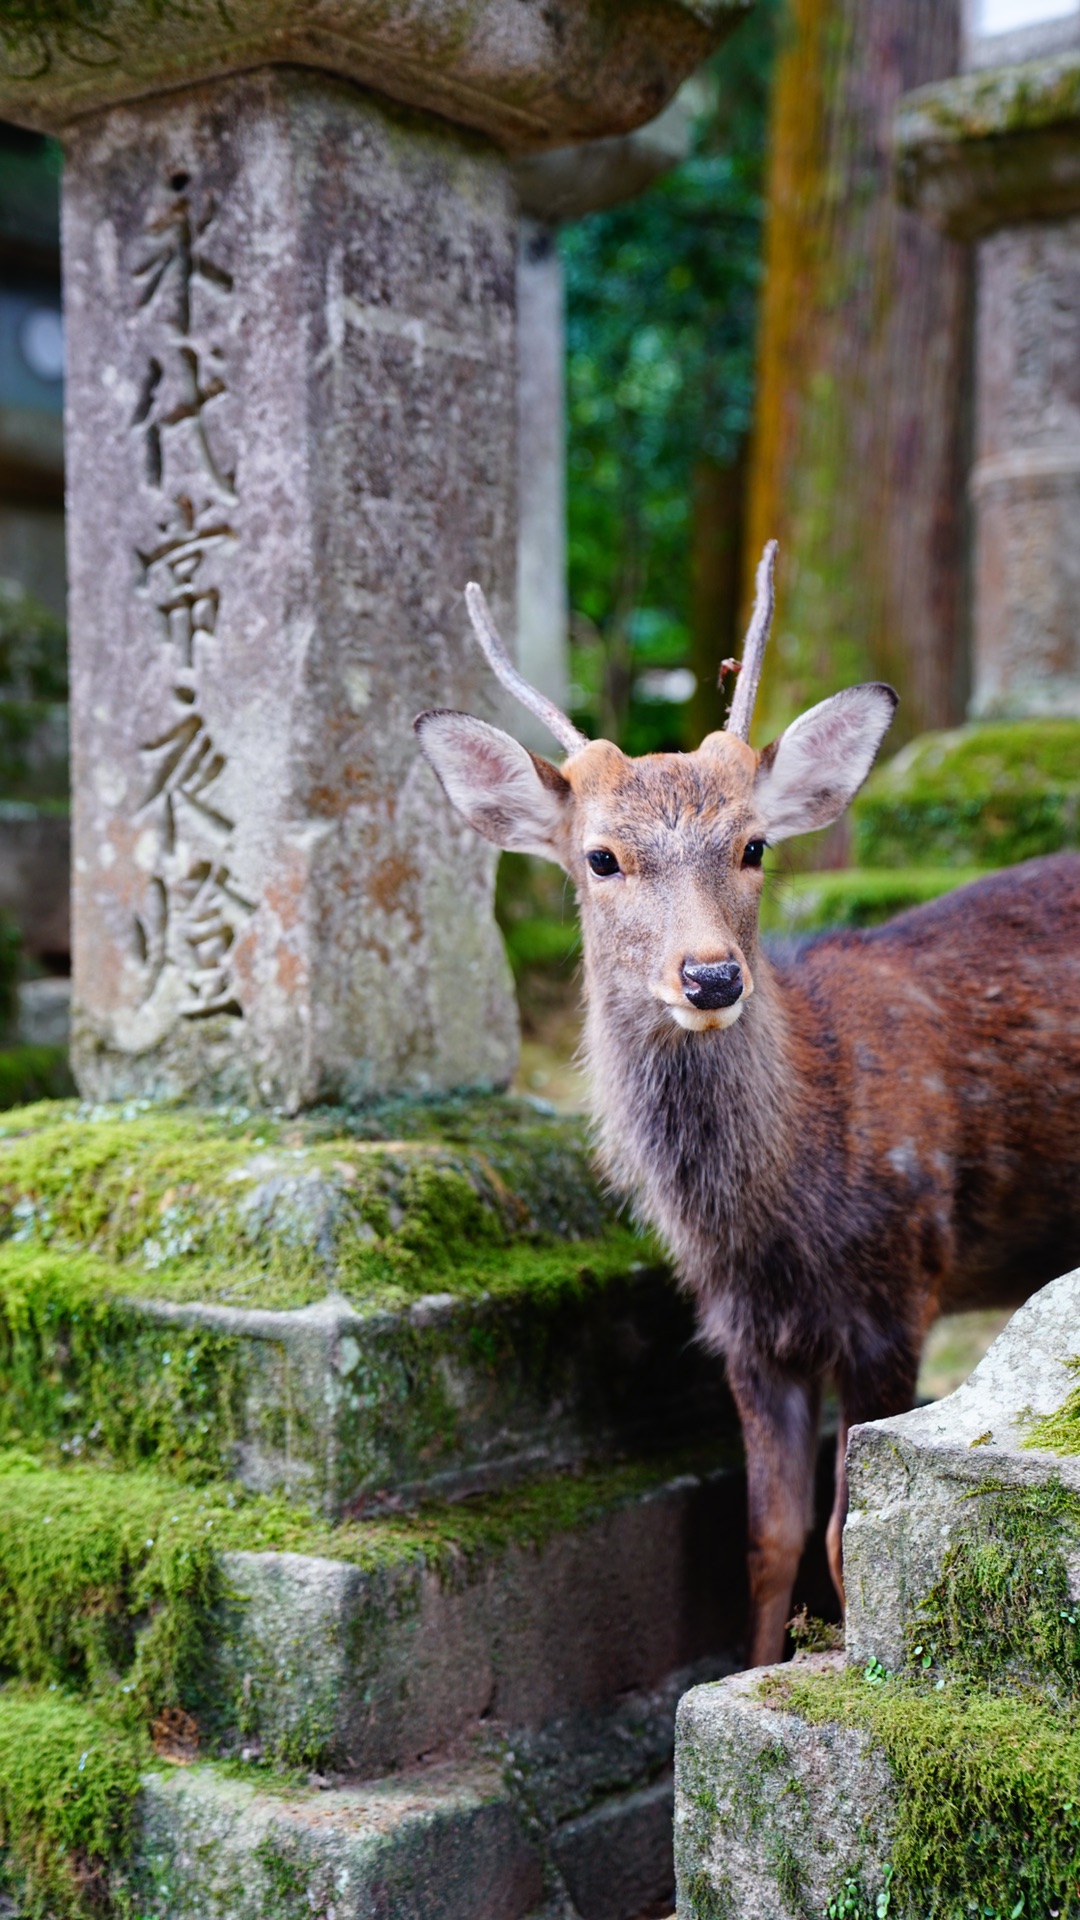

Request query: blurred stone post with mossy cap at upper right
[{"left": 897, "top": 27, "right": 1080, "bottom": 720}]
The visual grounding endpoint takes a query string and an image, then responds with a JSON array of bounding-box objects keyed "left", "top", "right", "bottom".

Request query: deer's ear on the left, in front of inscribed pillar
[{"left": 413, "top": 710, "right": 571, "bottom": 860}]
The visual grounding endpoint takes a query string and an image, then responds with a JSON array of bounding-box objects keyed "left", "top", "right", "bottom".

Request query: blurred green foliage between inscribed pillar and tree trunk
[{"left": 561, "top": 0, "right": 782, "bottom": 753}]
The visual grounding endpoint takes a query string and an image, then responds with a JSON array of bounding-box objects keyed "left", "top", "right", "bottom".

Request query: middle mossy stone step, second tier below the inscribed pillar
[{"left": 0, "top": 1455, "right": 746, "bottom": 1776}]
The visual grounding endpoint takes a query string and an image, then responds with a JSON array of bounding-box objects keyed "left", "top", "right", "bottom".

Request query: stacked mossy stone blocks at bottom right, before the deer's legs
[{"left": 675, "top": 1271, "right": 1080, "bottom": 1920}]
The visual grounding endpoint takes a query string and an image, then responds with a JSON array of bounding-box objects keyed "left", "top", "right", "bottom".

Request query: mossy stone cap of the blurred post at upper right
[{"left": 894, "top": 52, "right": 1080, "bottom": 240}]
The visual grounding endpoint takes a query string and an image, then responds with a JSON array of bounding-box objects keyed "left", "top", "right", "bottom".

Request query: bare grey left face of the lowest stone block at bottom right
[{"left": 675, "top": 1655, "right": 896, "bottom": 1920}]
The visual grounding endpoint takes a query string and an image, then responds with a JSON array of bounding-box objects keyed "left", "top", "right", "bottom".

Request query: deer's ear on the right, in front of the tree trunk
[{"left": 753, "top": 682, "right": 899, "bottom": 841}]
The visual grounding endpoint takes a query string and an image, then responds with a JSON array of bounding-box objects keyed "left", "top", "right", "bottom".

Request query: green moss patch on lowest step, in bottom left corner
[{"left": 0, "top": 1688, "right": 146, "bottom": 1920}]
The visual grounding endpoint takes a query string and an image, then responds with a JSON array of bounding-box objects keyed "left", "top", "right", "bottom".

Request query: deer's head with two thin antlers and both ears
[{"left": 413, "top": 541, "right": 897, "bottom": 1033}]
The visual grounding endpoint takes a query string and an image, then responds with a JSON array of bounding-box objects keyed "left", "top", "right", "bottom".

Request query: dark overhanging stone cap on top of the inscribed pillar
[{"left": 0, "top": 0, "right": 749, "bottom": 150}]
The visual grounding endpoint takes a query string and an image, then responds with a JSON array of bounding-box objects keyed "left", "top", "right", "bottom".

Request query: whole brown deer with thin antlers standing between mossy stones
[{"left": 415, "top": 541, "right": 1080, "bottom": 1667}]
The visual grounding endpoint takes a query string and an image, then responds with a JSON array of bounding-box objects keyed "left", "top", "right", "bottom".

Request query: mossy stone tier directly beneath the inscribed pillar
[{"left": 0, "top": 1098, "right": 736, "bottom": 1513}]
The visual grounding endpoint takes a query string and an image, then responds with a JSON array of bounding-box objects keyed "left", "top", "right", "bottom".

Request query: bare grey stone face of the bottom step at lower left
[{"left": 133, "top": 1761, "right": 544, "bottom": 1920}]
